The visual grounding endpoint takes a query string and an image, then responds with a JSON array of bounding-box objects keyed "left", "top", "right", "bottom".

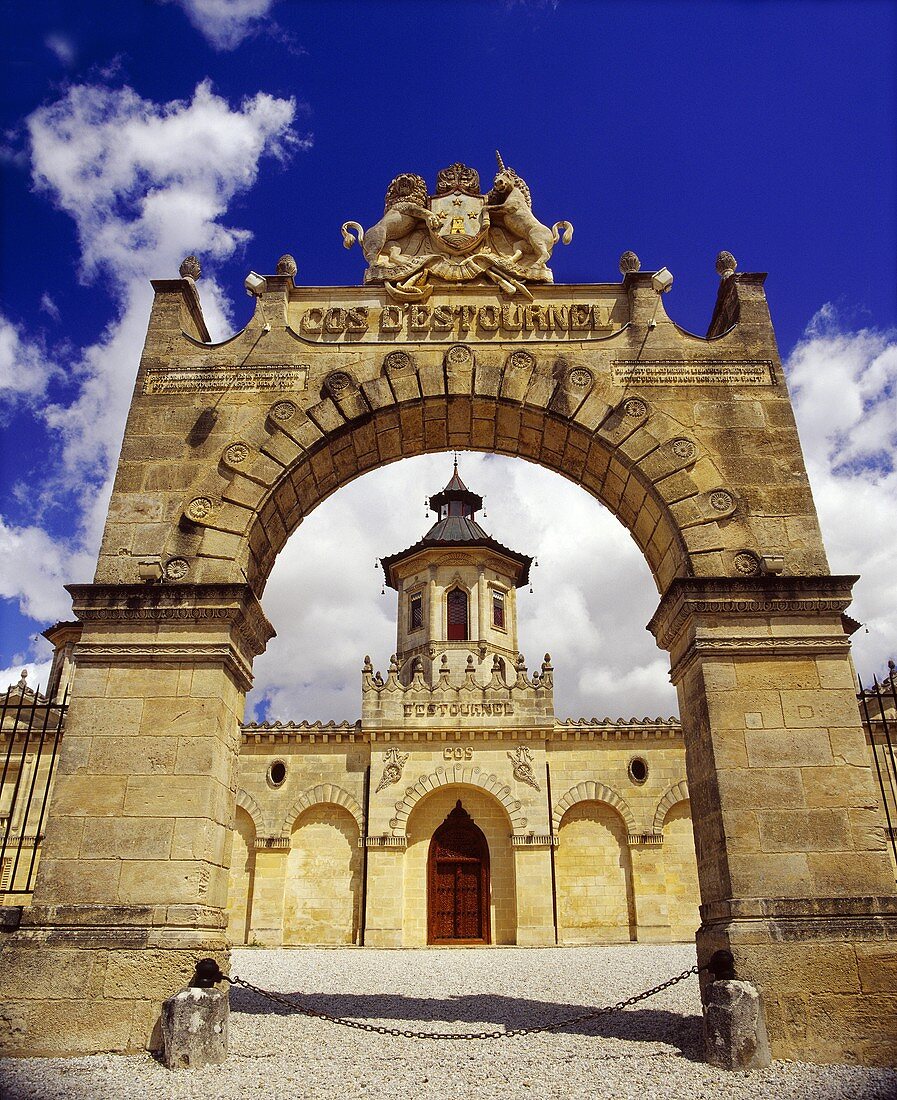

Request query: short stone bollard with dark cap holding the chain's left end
[{"left": 162, "top": 959, "right": 230, "bottom": 1069}]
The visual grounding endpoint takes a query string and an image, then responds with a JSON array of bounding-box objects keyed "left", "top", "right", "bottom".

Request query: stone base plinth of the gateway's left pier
[{"left": 0, "top": 906, "right": 229, "bottom": 1057}]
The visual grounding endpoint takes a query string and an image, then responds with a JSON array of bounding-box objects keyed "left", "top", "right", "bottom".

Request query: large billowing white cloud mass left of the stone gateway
[{"left": 0, "top": 83, "right": 303, "bottom": 638}]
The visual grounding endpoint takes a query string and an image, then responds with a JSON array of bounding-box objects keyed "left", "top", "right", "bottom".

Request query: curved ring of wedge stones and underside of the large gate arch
[{"left": 180, "top": 367, "right": 745, "bottom": 595}]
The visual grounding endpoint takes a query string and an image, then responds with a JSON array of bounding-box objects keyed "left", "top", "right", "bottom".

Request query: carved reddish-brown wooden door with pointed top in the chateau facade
[{"left": 427, "top": 799, "right": 491, "bottom": 944}]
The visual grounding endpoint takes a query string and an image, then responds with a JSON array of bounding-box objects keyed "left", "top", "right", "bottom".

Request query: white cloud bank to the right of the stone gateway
[{"left": 786, "top": 305, "right": 897, "bottom": 680}]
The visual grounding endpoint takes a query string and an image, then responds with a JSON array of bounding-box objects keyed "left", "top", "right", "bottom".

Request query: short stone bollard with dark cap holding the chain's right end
[{"left": 703, "top": 952, "right": 772, "bottom": 1069}]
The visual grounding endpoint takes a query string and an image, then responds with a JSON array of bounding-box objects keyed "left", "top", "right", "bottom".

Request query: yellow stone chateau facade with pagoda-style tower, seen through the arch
[{"left": 229, "top": 468, "right": 699, "bottom": 947}]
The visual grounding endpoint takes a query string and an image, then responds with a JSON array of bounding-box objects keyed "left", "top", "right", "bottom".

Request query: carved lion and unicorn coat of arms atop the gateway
[{"left": 342, "top": 152, "right": 573, "bottom": 301}]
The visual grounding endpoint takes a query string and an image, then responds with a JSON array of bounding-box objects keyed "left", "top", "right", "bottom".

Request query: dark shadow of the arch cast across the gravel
[{"left": 230, "top": 987, "right": 704, "bottom": 1062}]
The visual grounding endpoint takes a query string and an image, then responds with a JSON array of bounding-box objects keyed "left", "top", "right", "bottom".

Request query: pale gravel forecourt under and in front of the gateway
[{"left": 0, "top": 944, "right": 897, "bottom": 1100}]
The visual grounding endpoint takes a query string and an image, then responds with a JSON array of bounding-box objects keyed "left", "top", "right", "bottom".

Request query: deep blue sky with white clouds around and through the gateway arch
[{"left": 0, "top": 0, "right": 897, "bottom": 718}]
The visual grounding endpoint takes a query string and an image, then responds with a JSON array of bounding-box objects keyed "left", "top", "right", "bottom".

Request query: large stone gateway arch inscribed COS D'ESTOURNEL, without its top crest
[{"left": 2, "top": 261, "right": 897, "bottom": 1060}]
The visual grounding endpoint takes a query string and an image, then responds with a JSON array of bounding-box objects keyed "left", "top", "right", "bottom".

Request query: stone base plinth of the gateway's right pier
[{"left": 698, "top": 898, "right": 897, "bottom": 1066}]
